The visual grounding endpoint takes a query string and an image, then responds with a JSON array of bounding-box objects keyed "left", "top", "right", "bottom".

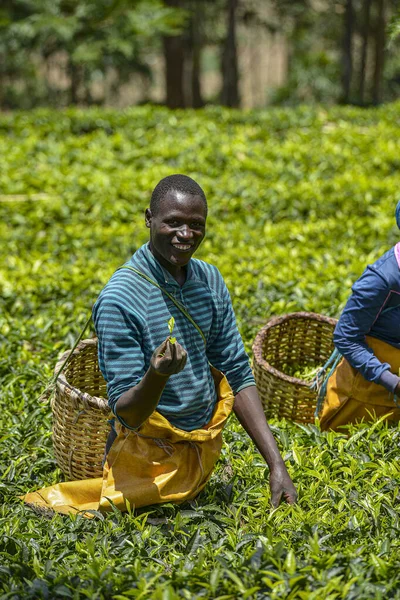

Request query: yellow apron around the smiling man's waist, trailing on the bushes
[{"left": 24, "top": 368, "right": 234, "bottom": 516}]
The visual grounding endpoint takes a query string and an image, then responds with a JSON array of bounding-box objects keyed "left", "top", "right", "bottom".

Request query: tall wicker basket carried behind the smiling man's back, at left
[{"left": 51, "top": 339, "right": 111, "bottom": 479}]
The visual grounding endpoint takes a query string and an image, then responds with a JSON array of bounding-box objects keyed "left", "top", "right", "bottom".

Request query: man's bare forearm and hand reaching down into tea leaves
[{"left": 233, "top": 385, "right": 297, "bottom": 507}]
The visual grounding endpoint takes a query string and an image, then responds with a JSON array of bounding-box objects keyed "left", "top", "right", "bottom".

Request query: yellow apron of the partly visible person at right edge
[{"left": 320, "top": 336, "right": 400, "bottom": 430}]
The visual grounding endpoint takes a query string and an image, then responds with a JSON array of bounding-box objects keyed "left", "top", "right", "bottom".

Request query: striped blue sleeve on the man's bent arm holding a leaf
[{"left": 93, "top": 296, "right": 146, "bottom": 418}]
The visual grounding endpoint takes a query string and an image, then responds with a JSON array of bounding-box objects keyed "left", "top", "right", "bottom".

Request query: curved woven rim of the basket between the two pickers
[{"left": 252, "top": 311, "right": 337, "bottom": 388}]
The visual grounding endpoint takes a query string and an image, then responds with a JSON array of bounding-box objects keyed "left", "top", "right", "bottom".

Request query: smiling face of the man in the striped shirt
[{"left": 146, "top": 190, "right": 207, "bottom": 270}]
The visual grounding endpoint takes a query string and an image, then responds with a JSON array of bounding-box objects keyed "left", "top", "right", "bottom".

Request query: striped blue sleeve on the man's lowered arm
[{"left": 206, "top": 269, "right": 255, "bottom": 394}]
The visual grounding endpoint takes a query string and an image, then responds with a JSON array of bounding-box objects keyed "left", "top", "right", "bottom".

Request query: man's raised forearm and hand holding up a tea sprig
[{"left": 114, "top": 339, "right": 187, "bottom": 429}]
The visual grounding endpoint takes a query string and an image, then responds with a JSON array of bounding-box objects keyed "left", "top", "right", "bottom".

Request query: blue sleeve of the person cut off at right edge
[{"left": 333, "top": 266, "right": 399, "bottom": 392}]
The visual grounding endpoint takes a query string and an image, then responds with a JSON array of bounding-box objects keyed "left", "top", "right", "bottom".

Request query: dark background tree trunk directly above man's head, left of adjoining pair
[{"left": 163, "top": 0, "right": 185, "bottom": 108}]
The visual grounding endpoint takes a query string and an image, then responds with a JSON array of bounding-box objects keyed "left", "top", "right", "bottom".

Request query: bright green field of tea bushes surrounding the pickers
[{"left": 0, "top": 104, "right": 400, "bottom": 600}]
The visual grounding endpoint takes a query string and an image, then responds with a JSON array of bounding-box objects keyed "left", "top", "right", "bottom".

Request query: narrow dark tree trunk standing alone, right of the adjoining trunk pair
[{"left": 221, "top": 0, "right": 240, "bottom": 107}]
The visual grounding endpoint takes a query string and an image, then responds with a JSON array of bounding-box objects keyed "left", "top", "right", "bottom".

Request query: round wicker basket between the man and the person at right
[{"left": 253, "top": 312, "right": 336, "bottom": 423}]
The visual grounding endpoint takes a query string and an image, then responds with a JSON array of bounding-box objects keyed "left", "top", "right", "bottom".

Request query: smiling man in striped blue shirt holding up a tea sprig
[{"left": 93, "top": 175, "right": 296, "bottom": 509}]
